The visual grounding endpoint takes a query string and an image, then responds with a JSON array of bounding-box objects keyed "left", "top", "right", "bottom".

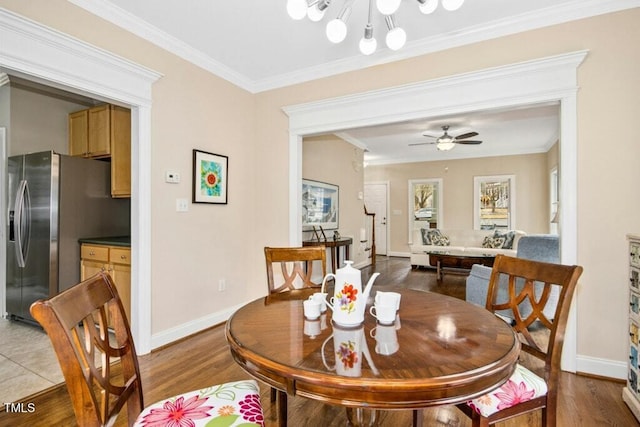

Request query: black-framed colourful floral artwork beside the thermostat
[{"left": 192, "top": 149, "right": 229, "bottom": 205}]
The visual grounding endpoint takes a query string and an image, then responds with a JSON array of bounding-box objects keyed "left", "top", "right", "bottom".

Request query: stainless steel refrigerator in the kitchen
[{"left": 6, "top": 151, "right": 130, "bottom": 321}]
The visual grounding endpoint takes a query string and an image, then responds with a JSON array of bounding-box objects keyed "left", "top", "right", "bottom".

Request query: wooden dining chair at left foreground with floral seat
[{"left": 31, "top": 272, "right": 264, "bottom": 427}]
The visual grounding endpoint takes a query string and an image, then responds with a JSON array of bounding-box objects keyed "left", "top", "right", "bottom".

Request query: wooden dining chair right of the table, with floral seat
[{"left": 458, "top": 255, "right": 582, "bottom": 427}]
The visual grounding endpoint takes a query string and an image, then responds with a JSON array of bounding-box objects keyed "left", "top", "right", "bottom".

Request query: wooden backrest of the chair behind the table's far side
[{"left": 264, "top": 246, "right": 327, "bottom": 294}]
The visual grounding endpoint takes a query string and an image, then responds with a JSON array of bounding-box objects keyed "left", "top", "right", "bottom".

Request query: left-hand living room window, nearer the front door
[{"left": 409, "top": 178, "right": 442, "bottom": 243}]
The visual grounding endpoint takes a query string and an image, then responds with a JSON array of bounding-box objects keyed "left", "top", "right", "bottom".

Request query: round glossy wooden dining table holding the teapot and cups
[{"left": 226, "top": 288, "right": 520, "bottom": 425}]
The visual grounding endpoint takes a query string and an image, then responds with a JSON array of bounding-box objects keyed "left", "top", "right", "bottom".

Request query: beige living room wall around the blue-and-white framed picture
[{"left": 302, "top": 135, "right": 370, "bottom": 265}]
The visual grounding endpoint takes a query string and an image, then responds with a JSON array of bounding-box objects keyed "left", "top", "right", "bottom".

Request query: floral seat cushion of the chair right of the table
[{"left": 467, "top": 364, "right": 547, "bottom": 417}]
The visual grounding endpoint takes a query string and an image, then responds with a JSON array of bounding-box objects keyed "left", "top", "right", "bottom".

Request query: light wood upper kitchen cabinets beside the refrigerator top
[{"left": 69, "top": 104, "right": 131, "bottom": 197}]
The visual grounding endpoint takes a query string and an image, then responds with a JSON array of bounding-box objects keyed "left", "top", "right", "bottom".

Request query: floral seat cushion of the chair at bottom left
[{"left": 134, "top": 380, "right": 264, "bottom": 427}]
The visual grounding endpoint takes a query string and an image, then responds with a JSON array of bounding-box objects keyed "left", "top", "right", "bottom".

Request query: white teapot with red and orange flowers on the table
[{"left": 322, "top": 261, "right": 380, "bottom": 326}]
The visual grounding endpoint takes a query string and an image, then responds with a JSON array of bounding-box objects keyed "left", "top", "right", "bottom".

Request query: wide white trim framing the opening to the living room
[{"left": 283, "top": 50, "right": 588, "bottom": 372}]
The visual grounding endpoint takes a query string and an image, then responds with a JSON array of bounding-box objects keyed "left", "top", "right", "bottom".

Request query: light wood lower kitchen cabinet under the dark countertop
[{"left": 80, "top": 243, "right": 131, "bottom": 321}]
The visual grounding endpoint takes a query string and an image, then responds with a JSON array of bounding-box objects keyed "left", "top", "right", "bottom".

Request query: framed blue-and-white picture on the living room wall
[{"left": 302, "top": 179, "right": 340, "bottom": 231}]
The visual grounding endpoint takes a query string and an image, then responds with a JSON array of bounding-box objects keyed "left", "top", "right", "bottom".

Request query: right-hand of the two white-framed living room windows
[{"left": 473, "top": 175, "right": 516, "bottom": 230}]
